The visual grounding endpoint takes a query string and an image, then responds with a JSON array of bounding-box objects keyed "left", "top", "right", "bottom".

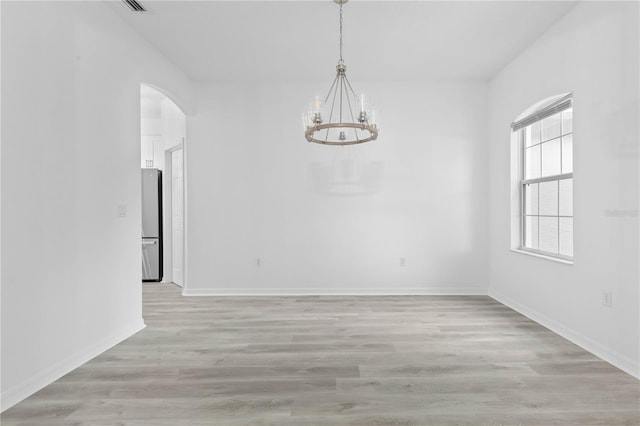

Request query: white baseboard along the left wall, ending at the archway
[{"left": 0, "top": 318, "right": 146, "bottom": 411}]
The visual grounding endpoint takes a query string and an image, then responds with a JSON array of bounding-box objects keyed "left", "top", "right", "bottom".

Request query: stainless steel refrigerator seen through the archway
[{"left": 142, "top": 169, "right": 162, "bottom": 281}]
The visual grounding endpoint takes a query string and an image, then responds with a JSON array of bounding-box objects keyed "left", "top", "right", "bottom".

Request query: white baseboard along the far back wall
[{"left": 182, "top": 287, "right": 487, "bottom": 296}]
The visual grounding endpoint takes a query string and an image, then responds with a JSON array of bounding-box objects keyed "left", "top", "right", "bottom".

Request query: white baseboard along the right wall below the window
[{"left": 489, "top": 290, "right": 640, "bottom": 379}]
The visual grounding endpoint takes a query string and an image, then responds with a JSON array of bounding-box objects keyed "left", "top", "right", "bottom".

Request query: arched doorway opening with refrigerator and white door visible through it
[{"left": 140, "top": 84, "right": 186, "bottom": 287}]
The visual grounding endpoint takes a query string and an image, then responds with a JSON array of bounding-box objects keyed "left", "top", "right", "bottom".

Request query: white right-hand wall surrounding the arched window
[{"left": 489, "top": 2, "right": 640, "bottom": 376}]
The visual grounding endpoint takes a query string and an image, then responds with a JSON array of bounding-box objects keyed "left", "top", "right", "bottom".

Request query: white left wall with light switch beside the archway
[{"left": 2, "top": 2, "right": 192, "bottom": 409}]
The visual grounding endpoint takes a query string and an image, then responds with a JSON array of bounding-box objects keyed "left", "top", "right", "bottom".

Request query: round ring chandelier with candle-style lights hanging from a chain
[{"left": 302, "top": 0, "right": 378, "bottom": 145}]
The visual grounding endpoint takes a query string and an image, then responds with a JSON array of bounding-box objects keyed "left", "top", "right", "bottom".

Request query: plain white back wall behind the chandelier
[{"left": 185, "top": 80, "right": 488, "bottom": 294}]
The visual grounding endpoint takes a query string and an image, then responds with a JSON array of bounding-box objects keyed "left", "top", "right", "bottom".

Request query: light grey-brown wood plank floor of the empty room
[{"left": 1, "top": 284, "right": 640, "bottom": 426}]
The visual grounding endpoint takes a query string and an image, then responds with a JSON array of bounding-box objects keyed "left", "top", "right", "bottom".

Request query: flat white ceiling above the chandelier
[{"left": 109, "top": 0, "right": 576, "bottom": 81}]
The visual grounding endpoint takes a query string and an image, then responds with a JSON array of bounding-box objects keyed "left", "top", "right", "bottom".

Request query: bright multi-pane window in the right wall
[{"left": 512, "top": 95, "right": 573, "bottom": 260}]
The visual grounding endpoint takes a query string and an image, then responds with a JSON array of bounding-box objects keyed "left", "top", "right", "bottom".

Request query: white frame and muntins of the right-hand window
[{"left": 511, "top": 93, "right": 574, "bottom": 263}]
